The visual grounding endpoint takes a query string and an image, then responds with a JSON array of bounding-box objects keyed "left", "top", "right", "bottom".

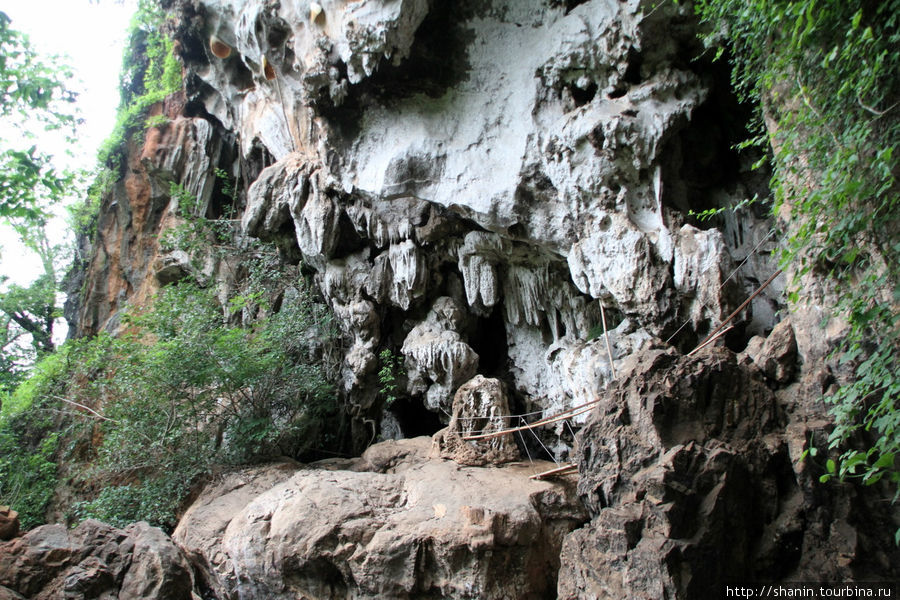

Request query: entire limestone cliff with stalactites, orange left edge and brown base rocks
[{"left": 45, "top": 0, "right": 900, "bottom": 598}]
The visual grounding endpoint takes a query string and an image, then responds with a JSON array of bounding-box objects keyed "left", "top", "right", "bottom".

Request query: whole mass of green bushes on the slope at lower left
[{"left": 0, "top": 264, "right": 337, "bottom": 528}]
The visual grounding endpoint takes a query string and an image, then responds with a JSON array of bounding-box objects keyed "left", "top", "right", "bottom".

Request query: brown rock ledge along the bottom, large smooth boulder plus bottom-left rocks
[{"left": 0, "top": 437, "right": 587, "bottom": 600}]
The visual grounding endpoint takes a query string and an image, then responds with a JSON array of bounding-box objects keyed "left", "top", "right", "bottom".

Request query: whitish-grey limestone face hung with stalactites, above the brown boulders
[{"left": 146, "top": 0, "right": 778, "bottom": 445}]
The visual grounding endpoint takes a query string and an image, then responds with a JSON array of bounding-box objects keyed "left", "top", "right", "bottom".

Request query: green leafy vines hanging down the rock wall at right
[{"left": 696, "top": 0, "right": 900, "bottom": 512}]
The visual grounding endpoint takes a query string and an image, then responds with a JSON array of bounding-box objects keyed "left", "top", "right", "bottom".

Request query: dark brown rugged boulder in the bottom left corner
[{"left": 0, "top": 519, "right": 195, "bottom": 600}]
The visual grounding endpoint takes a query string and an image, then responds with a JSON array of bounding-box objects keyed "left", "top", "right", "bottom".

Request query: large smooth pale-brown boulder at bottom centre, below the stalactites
[{"left": 174, "top": 438, "right": 584, "bottom": 600}]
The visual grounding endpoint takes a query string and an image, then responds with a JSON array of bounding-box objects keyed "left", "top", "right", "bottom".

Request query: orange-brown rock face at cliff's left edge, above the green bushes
[{"left": 65, "top": 94, "right": 246, "bottom": 336}]
